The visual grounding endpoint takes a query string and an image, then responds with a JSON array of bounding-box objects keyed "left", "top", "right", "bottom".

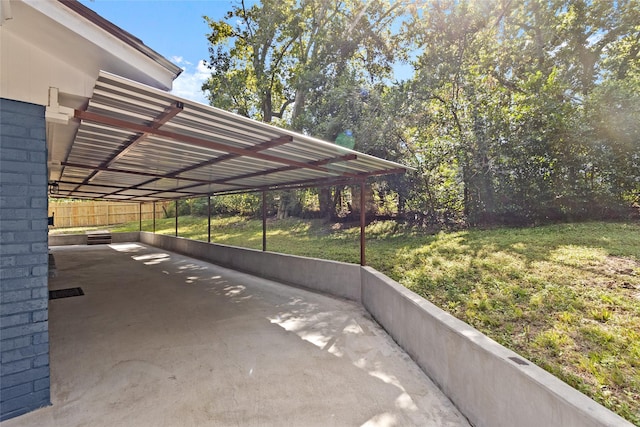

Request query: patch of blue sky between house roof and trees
[{"left": 80, "top": 0, "right": 232, "bottom": 104}]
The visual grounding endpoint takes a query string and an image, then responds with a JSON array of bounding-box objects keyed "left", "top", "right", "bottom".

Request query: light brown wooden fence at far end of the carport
[{"left": 49, "top": 201, "right": 168, "bottom": 228}]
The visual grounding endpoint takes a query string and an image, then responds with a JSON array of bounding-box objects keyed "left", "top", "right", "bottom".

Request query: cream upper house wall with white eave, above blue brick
[{"left": 0, "top": 1, "right": 180, "bottom": 108}]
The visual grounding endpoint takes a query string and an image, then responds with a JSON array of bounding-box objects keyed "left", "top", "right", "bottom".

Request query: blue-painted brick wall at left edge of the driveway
[{"left": 0, "top": 98, "right": 50, "bottom": 421}]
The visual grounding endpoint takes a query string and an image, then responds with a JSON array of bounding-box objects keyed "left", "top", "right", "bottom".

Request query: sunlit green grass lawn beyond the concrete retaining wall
[{"left": 52, "top": 217, "right": 640, "bottom": 426}]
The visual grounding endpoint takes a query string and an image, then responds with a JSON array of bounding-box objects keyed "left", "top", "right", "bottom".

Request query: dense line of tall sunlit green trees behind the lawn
[{"left": 203, "top": 0, "right": 640, "bottom": 224}]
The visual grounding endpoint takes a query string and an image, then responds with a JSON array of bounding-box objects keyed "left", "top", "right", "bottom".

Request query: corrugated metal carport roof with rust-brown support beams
[{"left": 59, "top": 72, "right": 407, "bottom": 201}]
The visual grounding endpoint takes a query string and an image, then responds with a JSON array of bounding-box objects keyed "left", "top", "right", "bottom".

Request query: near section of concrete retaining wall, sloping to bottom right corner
[{"left": 362, "top": 267, "right": 632, "bottom": 427}]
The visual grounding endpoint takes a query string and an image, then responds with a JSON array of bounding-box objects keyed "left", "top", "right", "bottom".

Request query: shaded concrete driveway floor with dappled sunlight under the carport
[{"left": 3, "top": 243, "right": 469, "bottom": 427}]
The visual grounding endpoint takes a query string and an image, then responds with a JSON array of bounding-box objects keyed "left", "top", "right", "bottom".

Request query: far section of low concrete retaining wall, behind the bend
[{"left": 140, "top": 232, "right": 361, "bottom": 302}]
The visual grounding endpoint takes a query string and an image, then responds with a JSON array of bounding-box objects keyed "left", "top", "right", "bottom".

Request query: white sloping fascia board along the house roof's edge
[{"left": 22, "top": 0, "right": 179, "bottom": 90}]
